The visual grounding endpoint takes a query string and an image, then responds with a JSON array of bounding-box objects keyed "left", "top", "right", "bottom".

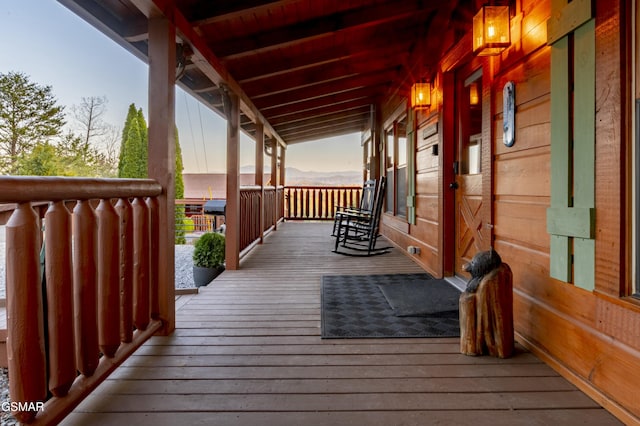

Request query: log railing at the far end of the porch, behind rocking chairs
[{"left": 284, "top": 186, "right": 362, "bottom": 220}]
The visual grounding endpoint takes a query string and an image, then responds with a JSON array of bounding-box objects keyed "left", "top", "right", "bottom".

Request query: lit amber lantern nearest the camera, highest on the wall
[{"left": 473, "top": 6, "right": 511, "bottom": 56}]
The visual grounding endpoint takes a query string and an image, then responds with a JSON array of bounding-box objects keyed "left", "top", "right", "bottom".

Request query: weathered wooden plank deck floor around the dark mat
[{"left": 64, "top": 223, "right": 619, "bottom": 426}]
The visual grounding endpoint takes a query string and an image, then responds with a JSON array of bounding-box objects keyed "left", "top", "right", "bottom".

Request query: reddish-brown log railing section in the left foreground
[{"left": 0, "top": 176, "right": 162, "bottom": 424}]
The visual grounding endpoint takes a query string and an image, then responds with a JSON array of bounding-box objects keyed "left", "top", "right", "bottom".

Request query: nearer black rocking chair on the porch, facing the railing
[{"left": 333, "top": 177, "right": 392, "bottom": 256}]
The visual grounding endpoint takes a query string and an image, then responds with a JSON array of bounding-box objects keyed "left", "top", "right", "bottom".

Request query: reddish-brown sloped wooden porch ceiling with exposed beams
[{"left": 59, "top": 0, "right": 473, "bottom": 144}]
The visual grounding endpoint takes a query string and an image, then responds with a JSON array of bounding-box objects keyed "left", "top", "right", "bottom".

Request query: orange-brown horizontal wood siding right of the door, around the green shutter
[{"left": 493, "top": 2, "right": 640, "bottom": 424}]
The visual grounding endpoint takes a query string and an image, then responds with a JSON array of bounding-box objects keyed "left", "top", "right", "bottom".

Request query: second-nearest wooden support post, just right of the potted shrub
[{"left": 224, "top": 91, "right": 240, "bottom": 270}]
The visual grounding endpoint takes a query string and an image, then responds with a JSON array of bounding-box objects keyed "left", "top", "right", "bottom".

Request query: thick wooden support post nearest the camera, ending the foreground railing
[{"left": 148, "top": 17, "right": 176, "bottom": 334}]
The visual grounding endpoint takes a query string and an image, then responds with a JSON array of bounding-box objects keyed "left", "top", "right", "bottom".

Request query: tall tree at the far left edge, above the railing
[{"left": 0, "top": 72, "right": 65, "bottom": 174}]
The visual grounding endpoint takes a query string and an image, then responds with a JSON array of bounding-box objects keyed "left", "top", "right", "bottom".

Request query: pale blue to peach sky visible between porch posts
[{"left": 0, "top": 0, "right": 362, "bottom": 173}]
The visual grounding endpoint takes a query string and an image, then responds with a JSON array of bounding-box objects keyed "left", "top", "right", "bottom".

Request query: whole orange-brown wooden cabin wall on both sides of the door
[{"left": 382, "top": 0, "right": 640, "bottom": 424}]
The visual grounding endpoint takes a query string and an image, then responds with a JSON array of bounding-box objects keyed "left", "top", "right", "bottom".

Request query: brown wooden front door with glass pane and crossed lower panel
[{"left": 453, "top": 72, "right": 484, "bottom": 278}]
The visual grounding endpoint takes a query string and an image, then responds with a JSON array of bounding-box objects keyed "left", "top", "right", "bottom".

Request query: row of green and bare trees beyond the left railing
[{"left": 0, "top": 72, "right": 184, "bottom": 242}]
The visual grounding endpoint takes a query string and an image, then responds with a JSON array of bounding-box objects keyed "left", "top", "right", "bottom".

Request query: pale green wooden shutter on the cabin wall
[{"left": 547, "top": 1, "right": 595, "bottom": 290}]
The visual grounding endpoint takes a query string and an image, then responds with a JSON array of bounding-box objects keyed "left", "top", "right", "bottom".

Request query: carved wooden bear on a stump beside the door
[{"left": 460, "top": 248, "right": 514, "bottom": 358}]
